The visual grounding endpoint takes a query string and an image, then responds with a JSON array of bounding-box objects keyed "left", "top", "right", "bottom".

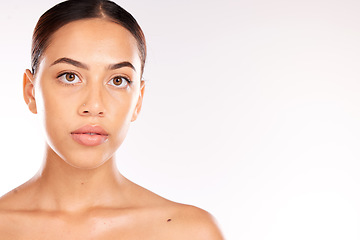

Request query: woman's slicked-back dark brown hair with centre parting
[{"left": 31, "top": 0, "right": 146, "bottom": 75}]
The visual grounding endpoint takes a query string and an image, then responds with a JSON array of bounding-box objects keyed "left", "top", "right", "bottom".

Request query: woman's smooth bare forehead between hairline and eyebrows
[{"left": 43, "top": 19, "right": 140, "bottom": 71}]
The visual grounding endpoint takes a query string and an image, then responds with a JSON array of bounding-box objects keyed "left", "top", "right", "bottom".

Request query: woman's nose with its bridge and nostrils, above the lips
[{"left": 80, "top": 81, "right": 105, "bottom": 116}]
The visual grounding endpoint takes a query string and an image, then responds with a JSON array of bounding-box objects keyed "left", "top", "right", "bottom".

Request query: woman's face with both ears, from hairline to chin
[{"left": 24, "top": 19, "right": 144, "bottom": 169}]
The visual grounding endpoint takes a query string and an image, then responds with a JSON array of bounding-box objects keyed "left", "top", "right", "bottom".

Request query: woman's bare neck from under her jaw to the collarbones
[{"left": 32, "top": 147, "right": 125, "bottom": 212}]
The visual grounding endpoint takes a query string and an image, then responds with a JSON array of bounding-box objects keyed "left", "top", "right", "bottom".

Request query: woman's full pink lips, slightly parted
[{"left": 71, "top": 125, "right": 109, "bottom": 146}]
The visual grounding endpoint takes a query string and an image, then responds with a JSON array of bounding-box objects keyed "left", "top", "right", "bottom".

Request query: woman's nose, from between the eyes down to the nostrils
[{"left": 79, "top": 86, "right": 105, "bottom": 117}]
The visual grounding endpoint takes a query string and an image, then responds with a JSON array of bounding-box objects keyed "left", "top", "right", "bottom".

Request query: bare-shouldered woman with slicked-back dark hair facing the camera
[{"left": 0, "top": 0, "right": 223, "bottom": 240}]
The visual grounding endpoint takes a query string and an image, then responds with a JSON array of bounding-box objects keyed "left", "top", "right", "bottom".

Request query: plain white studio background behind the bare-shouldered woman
[{"left": 0, "top": 0, "right": 360, "bottom": 240}]
